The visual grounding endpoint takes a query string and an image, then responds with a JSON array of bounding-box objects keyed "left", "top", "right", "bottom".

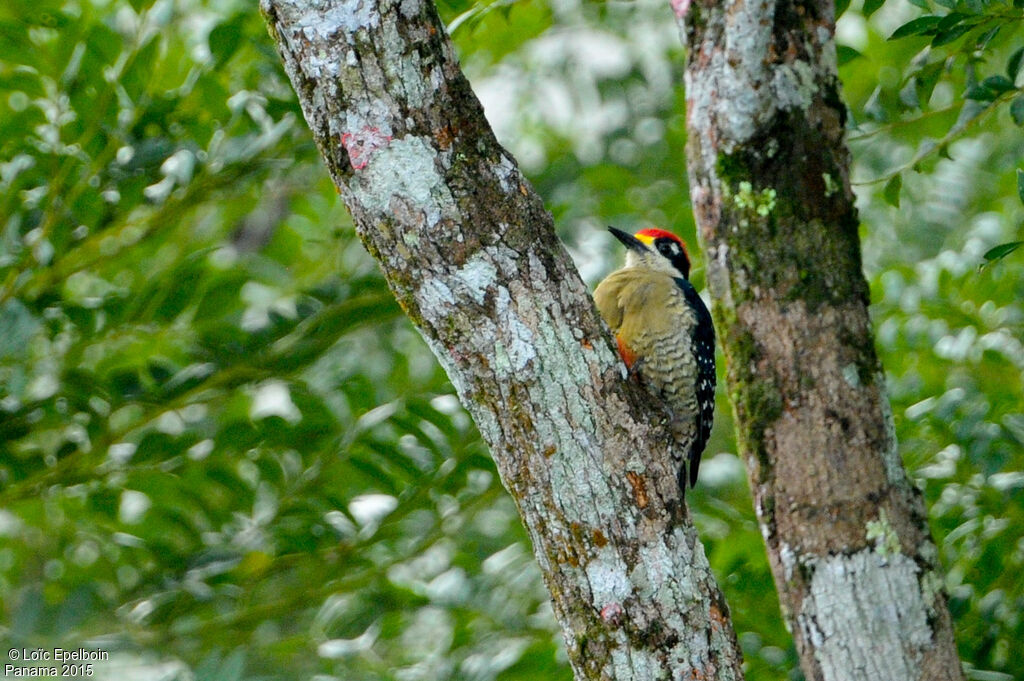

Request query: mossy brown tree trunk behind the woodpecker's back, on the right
[{"left": 673, "top": 0, "right": 964, "bottom": 681}]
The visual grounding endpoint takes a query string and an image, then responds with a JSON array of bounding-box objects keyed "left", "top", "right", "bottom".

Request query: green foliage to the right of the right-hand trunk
[{"left": 839, "top": 2, "right": 1024, "bottom": 681}]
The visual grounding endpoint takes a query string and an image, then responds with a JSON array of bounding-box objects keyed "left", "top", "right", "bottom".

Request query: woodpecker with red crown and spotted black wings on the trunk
[{"left": 594, "top": 227, "right": 715, "bottom": 492}]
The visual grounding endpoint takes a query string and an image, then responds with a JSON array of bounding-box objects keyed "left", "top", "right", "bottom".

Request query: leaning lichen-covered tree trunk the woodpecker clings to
[{"left": 262, "top": 0, "right": 742, "bottom": 680}]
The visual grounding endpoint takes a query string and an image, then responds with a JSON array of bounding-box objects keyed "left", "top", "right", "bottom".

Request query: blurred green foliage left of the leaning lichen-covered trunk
[{"left": 0, "top": 0, "right": 568, "bottom": 681}]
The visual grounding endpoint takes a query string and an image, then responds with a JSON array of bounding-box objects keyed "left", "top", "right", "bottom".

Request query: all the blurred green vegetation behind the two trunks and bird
[{"left": 0, "top": 0, "right": 1024, "bottom": 681}]
